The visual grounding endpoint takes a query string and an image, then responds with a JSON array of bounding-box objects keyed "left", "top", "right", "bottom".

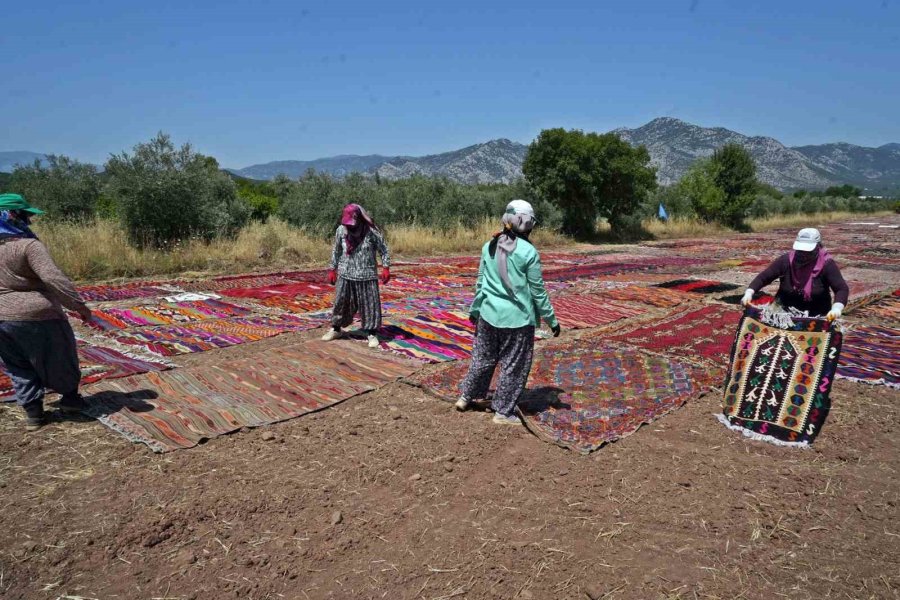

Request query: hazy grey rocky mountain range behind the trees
[{"left": 7, "top": 117, "right": 900, "bottom": 193}]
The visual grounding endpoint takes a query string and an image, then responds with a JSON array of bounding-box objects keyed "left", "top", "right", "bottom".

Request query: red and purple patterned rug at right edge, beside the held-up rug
[{"left": 837, "top": 325, "right": 900, "bottom": 388}]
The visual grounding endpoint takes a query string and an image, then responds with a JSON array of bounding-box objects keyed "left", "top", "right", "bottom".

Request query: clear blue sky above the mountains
[{"left": 0, "top": 0, "right": 900, "bottom": 167}]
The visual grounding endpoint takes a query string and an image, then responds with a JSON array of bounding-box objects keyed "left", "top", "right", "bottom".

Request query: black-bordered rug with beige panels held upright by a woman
[{"left": 719, "top": 308, "right": 843, "bottom": 446}]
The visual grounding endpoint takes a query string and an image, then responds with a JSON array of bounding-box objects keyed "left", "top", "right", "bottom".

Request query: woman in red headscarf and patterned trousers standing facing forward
[{"left": 322, "top": 204, "right": 391, "bottom": 348}]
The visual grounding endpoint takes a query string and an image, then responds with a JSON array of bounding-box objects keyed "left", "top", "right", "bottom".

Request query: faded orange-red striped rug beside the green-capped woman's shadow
[{"left": 85, "top": 341, "right": 419, "bottom": 452}]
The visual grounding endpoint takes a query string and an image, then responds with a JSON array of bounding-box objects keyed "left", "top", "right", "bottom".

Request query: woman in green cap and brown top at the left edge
[{"left": 0, "top": 194, "right": 91, "bottom": 431}]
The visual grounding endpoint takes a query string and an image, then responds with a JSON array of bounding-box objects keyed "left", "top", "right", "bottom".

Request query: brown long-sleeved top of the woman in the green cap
[{"left": 0, "top": 238, "right": 85, "bottom": 321}]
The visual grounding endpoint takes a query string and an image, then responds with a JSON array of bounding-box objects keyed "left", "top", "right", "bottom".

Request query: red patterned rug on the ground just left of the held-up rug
[{"left": 597, "top": 304, "right": 741, "bottom": 368}]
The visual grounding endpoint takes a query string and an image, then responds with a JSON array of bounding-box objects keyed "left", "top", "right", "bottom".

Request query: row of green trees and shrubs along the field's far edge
[{"left": 0, "top": 129, "right": 887, "bottom": 247}]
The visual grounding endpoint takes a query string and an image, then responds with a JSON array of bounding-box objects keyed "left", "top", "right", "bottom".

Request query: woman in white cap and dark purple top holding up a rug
[{"left": 741, "top": 228, "right": 850, "bottom": 321}]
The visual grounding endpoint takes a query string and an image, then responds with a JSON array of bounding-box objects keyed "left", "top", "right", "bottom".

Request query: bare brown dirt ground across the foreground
[{"left": 0, "top": 316, "right": 900, "bottom": 600}]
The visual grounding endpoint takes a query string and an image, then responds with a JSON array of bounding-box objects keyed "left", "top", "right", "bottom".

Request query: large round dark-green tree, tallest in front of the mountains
[{"left": 522, "top": 128, "right": 656, "bottom": 236}]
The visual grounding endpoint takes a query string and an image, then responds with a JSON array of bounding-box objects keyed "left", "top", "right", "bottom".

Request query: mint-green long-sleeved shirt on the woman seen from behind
[{"left": 470, "top": 238, "right": 557, "bottom": 329}]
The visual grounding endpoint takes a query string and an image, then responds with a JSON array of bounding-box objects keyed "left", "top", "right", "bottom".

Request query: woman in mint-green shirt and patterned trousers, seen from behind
[{"left": 456, "top": 200, "right": 560, "bottom": 425}]
